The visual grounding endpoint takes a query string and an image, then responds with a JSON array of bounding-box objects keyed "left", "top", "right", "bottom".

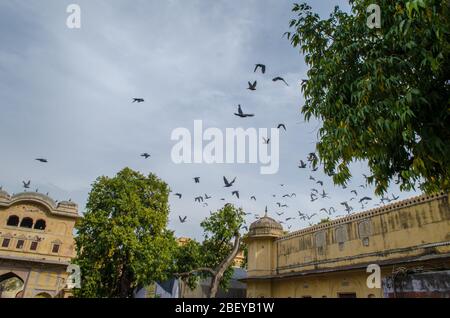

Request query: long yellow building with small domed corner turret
[{"left": 245, "top": 193, "right": 450, "bottom": 298}]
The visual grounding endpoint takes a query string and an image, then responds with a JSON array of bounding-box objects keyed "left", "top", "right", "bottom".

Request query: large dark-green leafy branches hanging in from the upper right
[{"left": 286, "top": 0, "right": 450, "bottom": 194}]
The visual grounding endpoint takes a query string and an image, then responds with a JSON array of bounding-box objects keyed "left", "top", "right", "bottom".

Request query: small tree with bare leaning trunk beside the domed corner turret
[{"left": 175, "top": 204, "right": 245, "bottom": 298}]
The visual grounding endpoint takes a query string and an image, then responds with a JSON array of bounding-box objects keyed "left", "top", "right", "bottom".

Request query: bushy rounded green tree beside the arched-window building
[{"left": 75, "top": 168, "right": 177, "bottom": 297}]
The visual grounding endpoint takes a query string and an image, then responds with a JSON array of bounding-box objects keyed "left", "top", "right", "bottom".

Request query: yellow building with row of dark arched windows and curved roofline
[{"left": 0, "top": 190, "right": 80, "bottom": 298}]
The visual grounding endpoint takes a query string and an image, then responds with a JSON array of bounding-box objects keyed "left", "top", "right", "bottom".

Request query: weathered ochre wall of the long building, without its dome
[{"left": 247, "top": 193, "right": 450, "bottom": 297}]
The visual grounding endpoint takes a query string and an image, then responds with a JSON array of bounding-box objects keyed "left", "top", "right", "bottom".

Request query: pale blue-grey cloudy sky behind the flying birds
[{"left": 0, "top": 0, "right": 415, "bottom": 239}]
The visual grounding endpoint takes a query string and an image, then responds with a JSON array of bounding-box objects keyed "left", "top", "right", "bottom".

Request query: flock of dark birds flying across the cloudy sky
[{"left": 13, "top": 64, "right": 399, "bottom": 234}]
